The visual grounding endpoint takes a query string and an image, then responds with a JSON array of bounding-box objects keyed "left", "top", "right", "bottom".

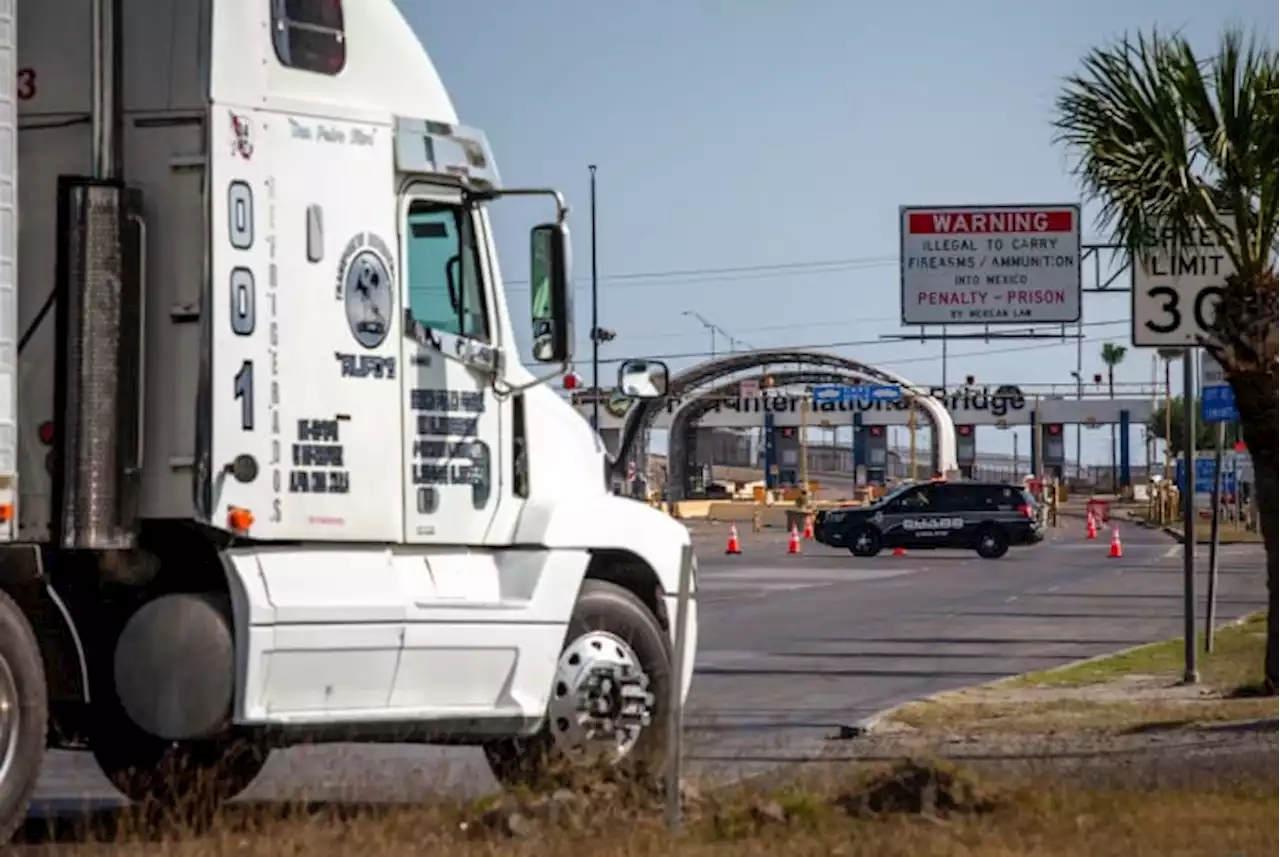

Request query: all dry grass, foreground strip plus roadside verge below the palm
[{"left": 22, "top": 618, "right": 1280, "bottom": 857}]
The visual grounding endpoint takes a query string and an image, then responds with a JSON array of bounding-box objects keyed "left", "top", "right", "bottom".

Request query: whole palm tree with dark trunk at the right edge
[{"left": 1055, "top": 28, "right": 1280, "bottom": 693}]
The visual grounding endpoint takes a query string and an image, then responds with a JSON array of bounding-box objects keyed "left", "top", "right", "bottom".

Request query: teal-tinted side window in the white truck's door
[{"left": 404, "top": 200, "right": 489, "bottom": 343}]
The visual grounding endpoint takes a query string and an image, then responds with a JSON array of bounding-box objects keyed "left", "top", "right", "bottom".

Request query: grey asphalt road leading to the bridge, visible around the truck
[{"left": 22, "top": 516, "right": 1266, "bottom": 815}]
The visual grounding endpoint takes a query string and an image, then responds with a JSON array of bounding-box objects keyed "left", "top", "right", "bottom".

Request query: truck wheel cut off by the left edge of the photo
[{"left": 0, "top": 592, "right": 49, "bottom": 842}]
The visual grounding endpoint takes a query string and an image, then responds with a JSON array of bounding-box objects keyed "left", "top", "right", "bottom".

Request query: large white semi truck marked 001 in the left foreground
[{"left": 0, "top": 0, "right": 696, "bottom": 835}]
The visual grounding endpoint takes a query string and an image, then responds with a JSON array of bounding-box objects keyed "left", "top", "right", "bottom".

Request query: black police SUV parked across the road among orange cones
[{"left": 813, "top": 482, "right": 1044, "bottom": 559}]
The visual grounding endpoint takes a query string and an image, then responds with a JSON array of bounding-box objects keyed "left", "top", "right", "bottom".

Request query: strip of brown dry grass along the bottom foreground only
[{"left": 15, "top": 762, "right": 1280, "bottom": 857}]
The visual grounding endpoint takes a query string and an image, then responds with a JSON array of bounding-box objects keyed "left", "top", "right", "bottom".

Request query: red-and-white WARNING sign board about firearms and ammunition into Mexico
[{"left": 899, "top": 203, "right": 1083, "bottom": 325}]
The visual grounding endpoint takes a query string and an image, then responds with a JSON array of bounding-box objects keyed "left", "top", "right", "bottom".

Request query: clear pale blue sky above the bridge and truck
[{"left": 401, "top": 0, "right": 1280, "bottom": 460}]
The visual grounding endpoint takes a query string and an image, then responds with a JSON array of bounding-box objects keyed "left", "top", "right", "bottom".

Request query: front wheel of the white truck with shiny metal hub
[{"left": 484, "top": 581, "right": 675, "bottom": 787}]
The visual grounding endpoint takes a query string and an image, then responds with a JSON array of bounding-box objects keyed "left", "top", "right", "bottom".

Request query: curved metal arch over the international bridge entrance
[{"left": 623, "top": 349, "right": 957, "bottom": 496}]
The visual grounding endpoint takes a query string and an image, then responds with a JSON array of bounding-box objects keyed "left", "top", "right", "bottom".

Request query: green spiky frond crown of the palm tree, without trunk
[{"left": 1055, "top": 28, "right": 1280, "bottom": 275}]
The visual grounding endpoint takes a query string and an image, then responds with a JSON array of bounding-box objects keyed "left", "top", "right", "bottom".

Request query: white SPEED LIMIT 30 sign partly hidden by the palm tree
[{"left": 1133, "top": 221, "right": 1235, "bottom": 348}]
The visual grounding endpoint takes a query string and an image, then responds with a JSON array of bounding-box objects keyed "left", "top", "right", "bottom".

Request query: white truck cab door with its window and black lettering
[{"left": 401, "top": 187, "right": 502, "bottom": 545}]
